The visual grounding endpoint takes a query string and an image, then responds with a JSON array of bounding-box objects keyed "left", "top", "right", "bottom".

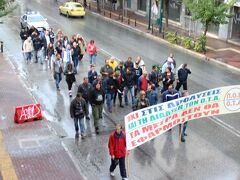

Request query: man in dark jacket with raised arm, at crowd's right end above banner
[{"left": 176, "top": 63, "right": 191, "bottom": 91}]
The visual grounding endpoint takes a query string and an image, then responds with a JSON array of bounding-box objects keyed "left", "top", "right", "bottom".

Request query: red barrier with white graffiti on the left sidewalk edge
[{"left": 14, "top": 104, "right": 42, "bottom": 123}]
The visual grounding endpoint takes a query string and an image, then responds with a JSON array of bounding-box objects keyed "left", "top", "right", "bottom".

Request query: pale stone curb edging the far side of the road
[{"left": 87, "top": 10, "right": 240, "bottom": 72}]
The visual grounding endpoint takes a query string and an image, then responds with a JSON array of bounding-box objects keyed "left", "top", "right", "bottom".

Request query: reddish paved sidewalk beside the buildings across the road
[{"left": 87, "top": 1, "right": 240, "bottom": 69}]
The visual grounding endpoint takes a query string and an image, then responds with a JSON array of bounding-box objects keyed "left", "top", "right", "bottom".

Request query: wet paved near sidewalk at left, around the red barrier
[{"left": 0, "top": 53, "right": 84, "bottom": 180}]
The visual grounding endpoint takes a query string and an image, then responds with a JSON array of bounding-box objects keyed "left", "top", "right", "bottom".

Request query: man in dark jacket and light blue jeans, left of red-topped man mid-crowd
[{"left": 123, "top": 67, "right": 135, "bottom": 106}]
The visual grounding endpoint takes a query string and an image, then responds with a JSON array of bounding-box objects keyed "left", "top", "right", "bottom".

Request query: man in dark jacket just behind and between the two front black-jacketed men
[{"left": 78, "top": 77, "right": 92, "bottom": 120}]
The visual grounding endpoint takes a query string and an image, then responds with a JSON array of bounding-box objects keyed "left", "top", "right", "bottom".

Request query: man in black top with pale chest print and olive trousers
[{"left": 89, "top": 83, "right": 105, "bottom": 134}]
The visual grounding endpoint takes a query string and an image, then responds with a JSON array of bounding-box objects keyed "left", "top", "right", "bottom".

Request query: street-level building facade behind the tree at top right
[{"left": 125, "top": 0, "right": 240, "bottom": 43}]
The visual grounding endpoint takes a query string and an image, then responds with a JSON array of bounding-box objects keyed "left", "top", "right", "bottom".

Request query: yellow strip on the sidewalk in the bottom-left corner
[{"left": 0, "top": 131, "right": 18, "bottom": 180}]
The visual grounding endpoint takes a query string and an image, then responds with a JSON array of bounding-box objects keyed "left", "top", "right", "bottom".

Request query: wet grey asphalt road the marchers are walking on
[{"left": 0, "top": 0, "right": 240, "bottom": 180}]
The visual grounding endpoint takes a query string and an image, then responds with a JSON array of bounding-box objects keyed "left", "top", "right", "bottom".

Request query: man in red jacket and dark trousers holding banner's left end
[{"left": 108, "top": 124, "right": 127, "bottom": 180}]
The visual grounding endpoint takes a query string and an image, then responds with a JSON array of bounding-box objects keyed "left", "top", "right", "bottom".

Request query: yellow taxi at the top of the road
[{"left": 59, "top": 2, "right": 85, "bottom": 18}]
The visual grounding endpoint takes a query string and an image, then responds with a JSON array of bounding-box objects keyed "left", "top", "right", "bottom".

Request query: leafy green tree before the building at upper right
[{"left": 183, "top": 0, "right": 236, "bottom": 36}]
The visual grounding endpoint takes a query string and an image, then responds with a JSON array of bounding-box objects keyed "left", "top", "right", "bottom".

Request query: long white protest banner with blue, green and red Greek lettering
[{"left": 125, "top": 85, "right": 240, "bottom": 150}]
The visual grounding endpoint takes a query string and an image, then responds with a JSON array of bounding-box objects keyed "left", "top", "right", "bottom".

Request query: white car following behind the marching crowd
[{"left": 20, "top": 11, "right": 49, "bottom": 31}]
